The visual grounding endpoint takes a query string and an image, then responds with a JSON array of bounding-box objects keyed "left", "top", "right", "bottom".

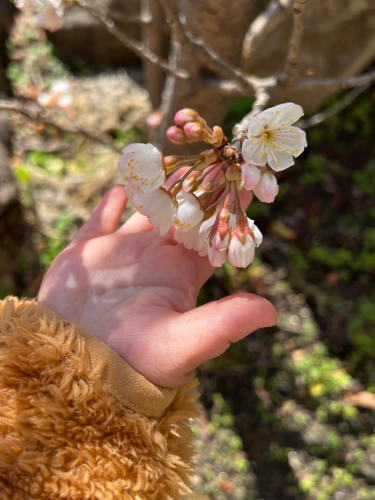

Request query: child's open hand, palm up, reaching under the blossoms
[{"left": 38, "top": 185, "right": 277, "bottom": 387}]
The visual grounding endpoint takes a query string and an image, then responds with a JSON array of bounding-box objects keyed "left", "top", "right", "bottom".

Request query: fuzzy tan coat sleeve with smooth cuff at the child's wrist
[{"left": 0, "top": 298, "right": 197, "bottom": 500}]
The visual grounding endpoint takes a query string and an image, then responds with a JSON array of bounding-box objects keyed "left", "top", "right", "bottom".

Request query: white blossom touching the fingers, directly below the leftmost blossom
[{"left": 132, "top": 189, "right": 177, "bottom": 236}]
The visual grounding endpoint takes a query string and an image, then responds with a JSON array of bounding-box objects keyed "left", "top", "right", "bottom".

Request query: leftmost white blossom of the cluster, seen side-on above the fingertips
[{"left": 118, "top": 143, "right": 165, "bottom": 196}]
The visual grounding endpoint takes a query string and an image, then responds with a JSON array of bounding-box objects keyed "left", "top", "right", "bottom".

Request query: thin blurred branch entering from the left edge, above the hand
[{"left": 0, "top": 99, "right": 121, "bottom": 153}]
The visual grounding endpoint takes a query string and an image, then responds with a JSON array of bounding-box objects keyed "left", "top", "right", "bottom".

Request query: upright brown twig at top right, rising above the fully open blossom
[{"left": 281, "top": 0, "right": 308, "bottom": 87}]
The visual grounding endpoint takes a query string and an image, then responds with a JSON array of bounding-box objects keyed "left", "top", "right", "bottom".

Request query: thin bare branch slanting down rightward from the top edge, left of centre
[{"left": 75, "top": 0, "right": 189, "bottom": 80}]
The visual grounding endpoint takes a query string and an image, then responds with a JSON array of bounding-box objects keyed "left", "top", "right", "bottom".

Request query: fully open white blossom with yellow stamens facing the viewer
[{"left": 242, "top": 102, "right": 307, "bottom": 172}]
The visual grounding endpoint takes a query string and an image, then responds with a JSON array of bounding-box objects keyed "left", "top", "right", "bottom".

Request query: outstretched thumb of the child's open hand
[{"left": 169, "top": 293, "right": 277, "bottom": 374}]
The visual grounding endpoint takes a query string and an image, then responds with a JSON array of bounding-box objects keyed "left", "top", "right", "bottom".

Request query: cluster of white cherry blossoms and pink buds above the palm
[{"left": 118, "top": 103, "right": 306, "bottom": 267}]
